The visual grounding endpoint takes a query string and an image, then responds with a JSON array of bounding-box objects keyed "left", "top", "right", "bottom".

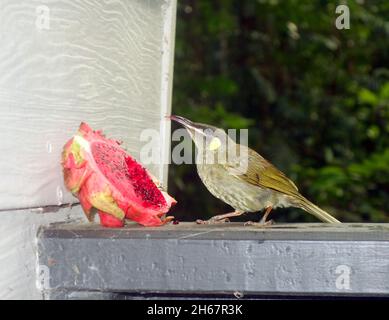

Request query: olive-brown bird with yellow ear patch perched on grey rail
[{"left": 169, "top": 115, "right": 341, "bottom": 227}]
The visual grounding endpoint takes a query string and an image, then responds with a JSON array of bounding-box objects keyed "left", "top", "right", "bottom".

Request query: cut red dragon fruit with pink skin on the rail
[{"left": 62, "top": 123, "right": 176, "bottom": 227}]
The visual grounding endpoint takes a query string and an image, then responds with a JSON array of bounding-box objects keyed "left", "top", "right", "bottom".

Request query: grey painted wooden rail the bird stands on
[{"left": 38, "top": 223, "right": 389, "bottom": 299}]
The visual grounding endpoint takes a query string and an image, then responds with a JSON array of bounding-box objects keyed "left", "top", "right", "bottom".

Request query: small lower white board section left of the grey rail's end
[{"left": 0, "top": 206, "right": 85, "bottom": 300}]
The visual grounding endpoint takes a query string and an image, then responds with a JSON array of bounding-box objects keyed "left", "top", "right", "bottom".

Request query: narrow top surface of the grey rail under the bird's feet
[{"left": 39, "top": 222, "right": 389, "bottom": 241}]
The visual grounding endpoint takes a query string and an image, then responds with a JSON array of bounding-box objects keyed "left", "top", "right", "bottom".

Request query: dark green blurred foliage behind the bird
[{"left": 169, "top": 0, "right": 389, "bottom": 222}]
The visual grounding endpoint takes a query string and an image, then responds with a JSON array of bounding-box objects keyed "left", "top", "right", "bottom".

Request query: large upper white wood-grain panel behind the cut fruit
[{"left": 0, "top": 0, "right": 176, "bottom": 209}]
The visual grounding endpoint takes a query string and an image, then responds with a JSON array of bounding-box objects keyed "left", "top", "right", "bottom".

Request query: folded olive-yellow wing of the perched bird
[{"left": 225, "top": 148, "right": 298, "bottom": 196}]
